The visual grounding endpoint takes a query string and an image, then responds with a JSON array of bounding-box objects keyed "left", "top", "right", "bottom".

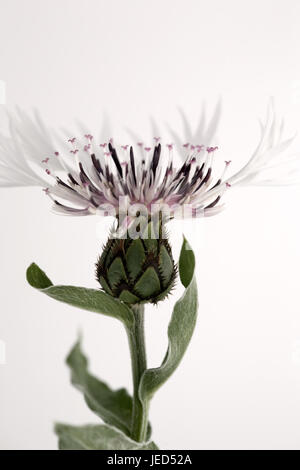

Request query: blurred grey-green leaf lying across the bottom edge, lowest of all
[{"left": 55, "top": 424, "right": 158, "bottom": 450}]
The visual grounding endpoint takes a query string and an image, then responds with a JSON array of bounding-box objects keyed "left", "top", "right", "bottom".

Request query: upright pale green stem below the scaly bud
[{"left": 127, "top": 305, "right": 148, "bottom": 442}]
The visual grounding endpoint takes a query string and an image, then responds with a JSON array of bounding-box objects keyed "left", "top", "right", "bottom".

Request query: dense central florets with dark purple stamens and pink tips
[{"left": 46, "top": 138, "right": 227, "bottom": 222}]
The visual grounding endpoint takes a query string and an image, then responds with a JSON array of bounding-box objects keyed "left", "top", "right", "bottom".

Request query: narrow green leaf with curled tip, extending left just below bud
[{"left": 26, "top": 263, "right": 134, "bottom": 328}]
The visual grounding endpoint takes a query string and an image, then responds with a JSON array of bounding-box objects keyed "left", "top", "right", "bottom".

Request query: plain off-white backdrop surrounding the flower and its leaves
[{"left": 0, "top": 0, "right": 300, "bottom": 449}]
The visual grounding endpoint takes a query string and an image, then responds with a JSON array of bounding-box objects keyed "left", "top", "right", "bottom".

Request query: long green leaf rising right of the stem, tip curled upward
[{"left": 139, "top": 239, "right": 198, "bottom": 402}]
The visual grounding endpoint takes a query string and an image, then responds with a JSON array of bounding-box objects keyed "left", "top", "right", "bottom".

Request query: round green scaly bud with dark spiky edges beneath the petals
[{"left": 96, "top": 223, "right": 177, "bottom": 304}]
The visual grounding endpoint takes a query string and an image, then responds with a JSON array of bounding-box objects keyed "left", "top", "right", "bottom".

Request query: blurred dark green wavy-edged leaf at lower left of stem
[{"left": 66, "top": 340, "right": 132, "bottom": 435}]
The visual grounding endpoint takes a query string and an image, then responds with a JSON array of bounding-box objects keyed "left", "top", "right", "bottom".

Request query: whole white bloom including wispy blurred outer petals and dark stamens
[{"left": 0, "top": 104, "right": 299, "bottom": 217}]
